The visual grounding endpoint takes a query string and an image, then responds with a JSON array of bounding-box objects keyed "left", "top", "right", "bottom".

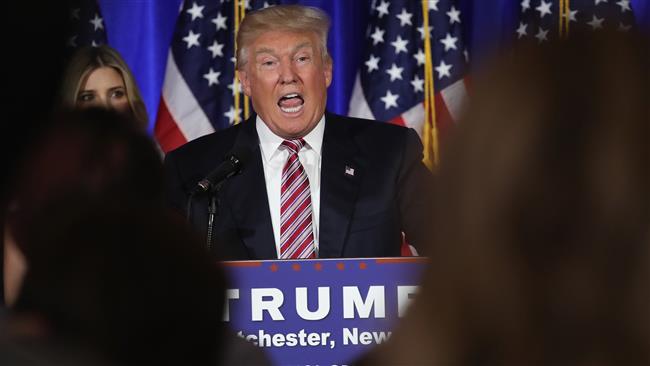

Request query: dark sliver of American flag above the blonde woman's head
[{"left": 67, "top": 0, "right": 108, "bottom": 52}]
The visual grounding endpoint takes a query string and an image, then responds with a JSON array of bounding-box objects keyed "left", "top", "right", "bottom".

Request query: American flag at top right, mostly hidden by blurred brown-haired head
[{"left": 515, "top": 0, "right": 635, "bottom": 43}]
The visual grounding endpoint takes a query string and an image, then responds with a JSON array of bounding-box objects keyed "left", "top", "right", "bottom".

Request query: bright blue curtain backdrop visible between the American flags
[{"left": 99, "top": 0, "right": 650, "bottom": 133}]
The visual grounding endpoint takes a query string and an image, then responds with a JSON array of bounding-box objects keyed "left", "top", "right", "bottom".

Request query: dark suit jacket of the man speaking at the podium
[{"left": 165, "top": 113, "right": 432, "bottom": 260}]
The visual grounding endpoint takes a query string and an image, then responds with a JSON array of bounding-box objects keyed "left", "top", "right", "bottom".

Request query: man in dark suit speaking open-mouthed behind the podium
[{"left": 165, "top": 5, "right": 431, "bottom": 259}]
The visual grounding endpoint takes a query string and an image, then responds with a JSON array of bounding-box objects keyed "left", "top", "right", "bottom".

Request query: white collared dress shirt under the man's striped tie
[{"left": 255, "top": 116, "right": 325, "bottom": 258}]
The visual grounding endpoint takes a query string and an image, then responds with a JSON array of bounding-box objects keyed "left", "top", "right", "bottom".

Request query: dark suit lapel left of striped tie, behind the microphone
[{"left": 228, "top": 116, "right": 277, "bottom": 259}]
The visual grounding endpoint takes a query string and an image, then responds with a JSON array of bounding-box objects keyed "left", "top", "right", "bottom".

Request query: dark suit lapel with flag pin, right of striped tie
[{"left": 319, "top": 114, "right": 363, "bottom": 258}]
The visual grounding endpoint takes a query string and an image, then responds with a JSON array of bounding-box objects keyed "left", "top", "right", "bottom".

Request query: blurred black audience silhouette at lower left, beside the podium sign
[{"left": 7, "top": 201, "right": 225, "bottom": 365}]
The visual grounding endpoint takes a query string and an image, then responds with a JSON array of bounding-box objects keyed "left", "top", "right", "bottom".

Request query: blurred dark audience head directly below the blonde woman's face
[{"left": 4, "top": 109, "right": 164, "bottom": 305}]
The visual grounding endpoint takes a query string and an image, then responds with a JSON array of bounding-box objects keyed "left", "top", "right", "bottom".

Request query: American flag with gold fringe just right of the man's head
[{"left": 349, "top": 0, "right": 468, "bottom": 169}]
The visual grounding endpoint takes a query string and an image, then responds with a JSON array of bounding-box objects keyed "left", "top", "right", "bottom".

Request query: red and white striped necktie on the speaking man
[{"left": 280, "top": 139, "right": 315, "bottom": 259}]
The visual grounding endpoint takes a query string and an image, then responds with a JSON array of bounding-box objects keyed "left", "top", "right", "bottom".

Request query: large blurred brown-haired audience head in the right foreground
[{"left": 373, "top": 30, "right": 650, "bottom": 365}]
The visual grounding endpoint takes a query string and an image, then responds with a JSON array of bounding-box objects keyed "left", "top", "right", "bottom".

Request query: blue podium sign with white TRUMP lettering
[{"left": 224, "top": 258, "right": 426, "bottom": 365}]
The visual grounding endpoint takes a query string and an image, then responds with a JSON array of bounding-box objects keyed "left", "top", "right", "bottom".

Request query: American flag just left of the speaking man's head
[{"left": 154, "top": 0, "right": 274, "bottom": 152}]
